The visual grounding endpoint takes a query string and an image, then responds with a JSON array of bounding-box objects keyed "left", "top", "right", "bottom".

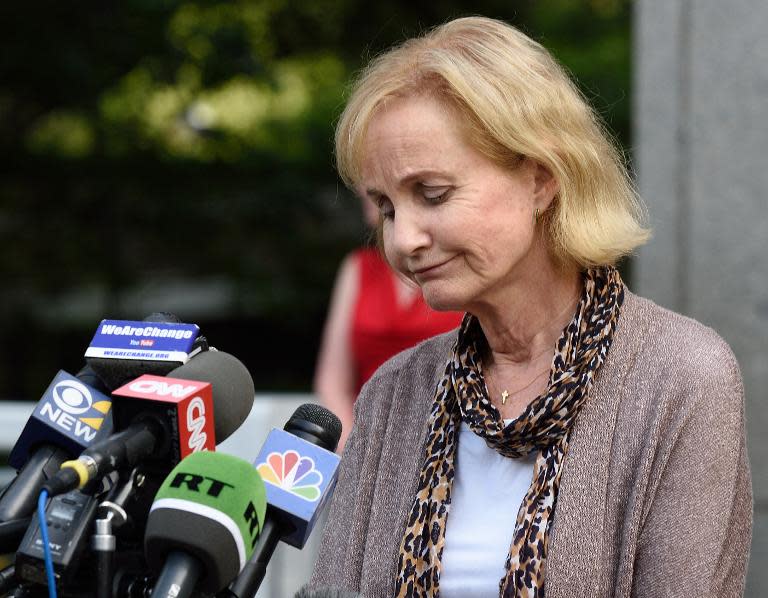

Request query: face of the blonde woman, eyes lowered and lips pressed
[{"left": 359, "top": 97, "right": 556, "bottom": 311}]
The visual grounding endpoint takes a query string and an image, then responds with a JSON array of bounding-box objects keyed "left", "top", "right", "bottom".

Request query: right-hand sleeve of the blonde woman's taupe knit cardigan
[{"left": 632, "top": 337, "right": 752, "bottom": 598}]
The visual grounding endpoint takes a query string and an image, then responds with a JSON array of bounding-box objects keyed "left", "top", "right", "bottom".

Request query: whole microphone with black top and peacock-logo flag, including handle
[{"left": 227, "top": 403, "right": 341, "bottom": 598}]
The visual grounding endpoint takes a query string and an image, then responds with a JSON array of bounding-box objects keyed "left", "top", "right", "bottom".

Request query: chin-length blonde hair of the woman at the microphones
[{"left": 336, "top": 17, "right": 650, "bottom": 267}]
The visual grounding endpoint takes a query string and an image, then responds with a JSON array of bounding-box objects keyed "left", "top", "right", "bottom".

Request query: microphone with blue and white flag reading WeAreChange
[{"left": 85, "top": 312, "right": 208, "bottom": 390}]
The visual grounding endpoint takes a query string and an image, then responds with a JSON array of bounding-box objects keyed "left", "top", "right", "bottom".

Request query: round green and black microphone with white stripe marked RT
[{"left": 144, "top": 452, "right": 267, "bottom": 598}]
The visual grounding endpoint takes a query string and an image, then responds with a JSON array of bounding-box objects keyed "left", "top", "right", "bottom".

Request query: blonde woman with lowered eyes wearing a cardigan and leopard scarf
[{"left": 312, "top": 18, "right": 752, "bottom": 598}]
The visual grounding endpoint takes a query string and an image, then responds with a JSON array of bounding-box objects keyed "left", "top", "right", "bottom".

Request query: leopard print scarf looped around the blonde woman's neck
[{"left": 395, "top": 267, "right": 624, "bottom": 598}]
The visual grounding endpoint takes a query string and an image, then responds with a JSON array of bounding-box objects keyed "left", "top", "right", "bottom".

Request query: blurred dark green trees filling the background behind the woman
[{"left": 0, "top": 0, "right": 631, "bottom": 398}]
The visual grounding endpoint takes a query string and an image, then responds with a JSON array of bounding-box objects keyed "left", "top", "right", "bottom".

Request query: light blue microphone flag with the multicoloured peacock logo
[{"left": 254, "top": 428, "right": 339, "bottom": 548}]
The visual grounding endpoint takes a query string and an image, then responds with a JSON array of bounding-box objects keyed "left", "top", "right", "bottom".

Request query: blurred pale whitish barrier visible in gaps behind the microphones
[{"left": 0, "top": 394, "right": 323, "bottom": 598}]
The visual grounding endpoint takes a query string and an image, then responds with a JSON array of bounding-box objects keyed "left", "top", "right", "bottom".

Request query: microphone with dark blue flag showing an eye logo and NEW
[{"left": 0, "top": 368, "right": 112, "bottom": 524}]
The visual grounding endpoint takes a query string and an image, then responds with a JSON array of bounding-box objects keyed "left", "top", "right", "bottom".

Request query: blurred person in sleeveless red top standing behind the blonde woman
[{"left": 314, "top": 199, "right": 463, "bottom": 452}]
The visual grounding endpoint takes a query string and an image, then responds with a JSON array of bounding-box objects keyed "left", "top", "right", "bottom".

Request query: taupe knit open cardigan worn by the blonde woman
[{"left": 311, "top": 292, "right": 752, "bottom": 598}]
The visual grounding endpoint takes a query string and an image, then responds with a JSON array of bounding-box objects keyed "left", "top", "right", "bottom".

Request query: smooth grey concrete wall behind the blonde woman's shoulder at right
[{"left": 634, "top": 0, "right": 768, "bottom": 597}]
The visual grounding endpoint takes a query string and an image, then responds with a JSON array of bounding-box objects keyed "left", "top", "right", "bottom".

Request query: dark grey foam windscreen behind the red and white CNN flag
[{"left": 168, "top": 350, "right": 255, "bottom": 443}]
